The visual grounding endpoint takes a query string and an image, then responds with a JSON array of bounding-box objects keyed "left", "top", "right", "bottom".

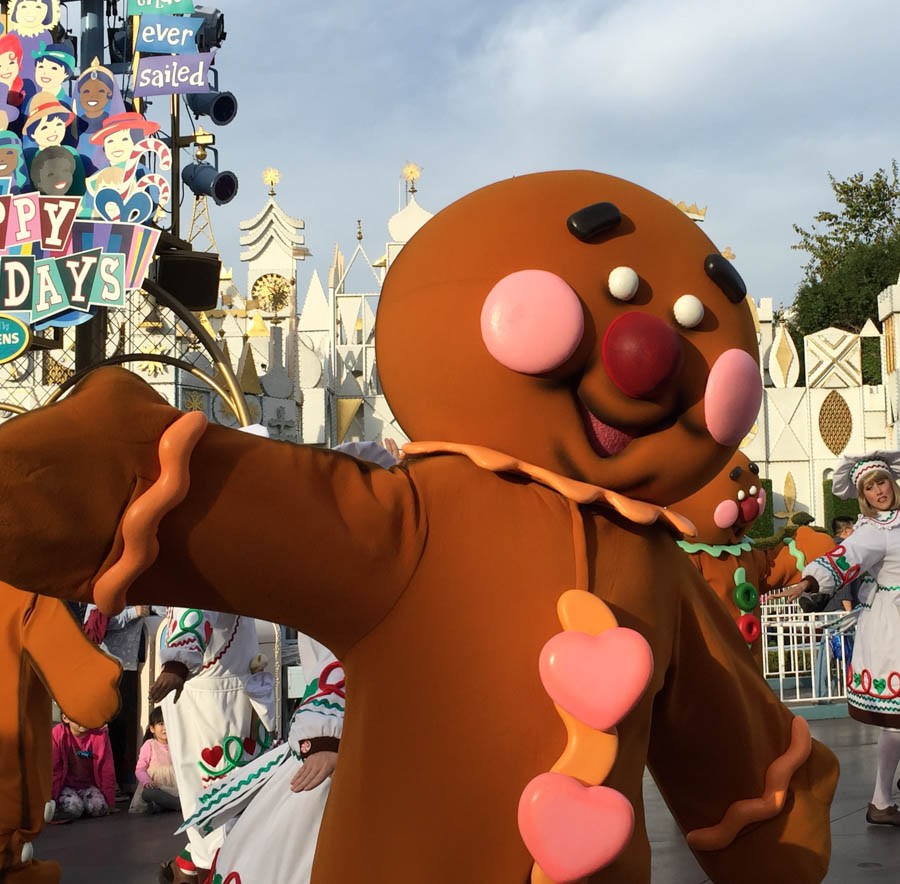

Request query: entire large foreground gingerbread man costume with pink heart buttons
[{"left": 0, "top": 172, "right": 837, "bottom": 884}]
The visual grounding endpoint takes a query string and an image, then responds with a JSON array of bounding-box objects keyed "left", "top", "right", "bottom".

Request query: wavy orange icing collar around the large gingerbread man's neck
[{"left": 403, "top": 442, "right": 697, "bottom": 537}]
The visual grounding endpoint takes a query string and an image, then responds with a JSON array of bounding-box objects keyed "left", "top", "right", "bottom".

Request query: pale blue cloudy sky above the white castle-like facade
[{"left": 183, "top": 0, "right": 900, "bottom": 305}]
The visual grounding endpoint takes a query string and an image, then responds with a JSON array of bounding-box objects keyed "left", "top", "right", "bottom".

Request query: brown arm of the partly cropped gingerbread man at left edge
[{"left": 23, "top": 596, "right": 122, "bottom": 727}]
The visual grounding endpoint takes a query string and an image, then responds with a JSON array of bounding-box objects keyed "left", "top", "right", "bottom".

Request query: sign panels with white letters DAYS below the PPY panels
[{"left": 0, "top": 249, "right": 126, "bottom": 325}]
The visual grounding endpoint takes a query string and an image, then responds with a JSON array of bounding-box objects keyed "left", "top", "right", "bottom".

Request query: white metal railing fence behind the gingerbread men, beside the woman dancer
[{"left": 760, "top": 599, "right": 857, "bottom": 704}]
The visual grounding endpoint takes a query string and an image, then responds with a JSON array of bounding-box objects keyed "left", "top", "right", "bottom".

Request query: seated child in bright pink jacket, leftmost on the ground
[{"left": 52, "top": 715, "right": 116, "bottom": 820}]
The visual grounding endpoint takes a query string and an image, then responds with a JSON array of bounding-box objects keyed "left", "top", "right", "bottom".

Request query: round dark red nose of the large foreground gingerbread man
[{"left": 603, "top": 312, "right": 684, "bottom": 399}]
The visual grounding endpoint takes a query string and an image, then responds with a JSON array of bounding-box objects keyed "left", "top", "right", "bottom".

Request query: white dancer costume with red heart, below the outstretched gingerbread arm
[{"left": 160, "top": 608, "right": 275, "bottom": 869}]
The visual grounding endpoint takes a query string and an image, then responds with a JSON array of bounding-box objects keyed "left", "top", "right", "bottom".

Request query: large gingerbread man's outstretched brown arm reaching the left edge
[{"left": 0, "top": 369, "right": 427, "bottom": 653}]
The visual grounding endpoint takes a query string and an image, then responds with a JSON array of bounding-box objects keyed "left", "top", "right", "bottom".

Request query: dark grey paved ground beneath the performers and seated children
[{"left": 35, "top": 718, "right": 900, "bottom": 884}]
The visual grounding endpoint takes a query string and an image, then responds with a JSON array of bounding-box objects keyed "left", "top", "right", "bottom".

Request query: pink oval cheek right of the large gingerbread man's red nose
[{"left": 703, "top": 350, "right": 762, "bottom": 446}]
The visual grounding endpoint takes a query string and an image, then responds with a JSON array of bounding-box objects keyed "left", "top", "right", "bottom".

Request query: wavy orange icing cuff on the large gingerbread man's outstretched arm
[{"left": 94, "top": 411, "right": 208, "bottom": 615}]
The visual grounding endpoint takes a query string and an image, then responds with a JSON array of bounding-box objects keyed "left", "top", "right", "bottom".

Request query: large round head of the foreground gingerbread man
[{"left": 377, "top": 171, "right": 762, "bottom": 503}]
